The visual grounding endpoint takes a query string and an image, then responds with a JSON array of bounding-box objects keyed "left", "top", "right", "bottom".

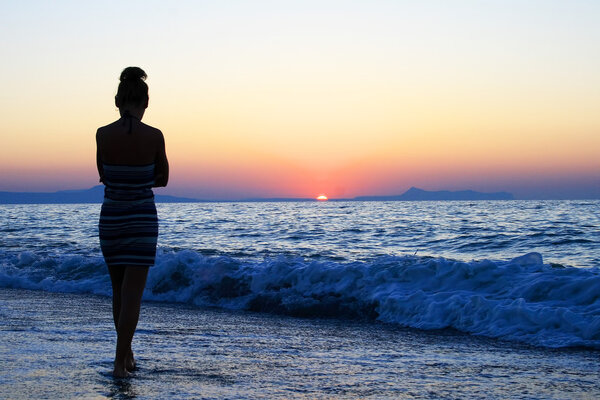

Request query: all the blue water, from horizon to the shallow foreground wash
[{"left": 0, "top": 200, "right": 600, "bottom": 399}]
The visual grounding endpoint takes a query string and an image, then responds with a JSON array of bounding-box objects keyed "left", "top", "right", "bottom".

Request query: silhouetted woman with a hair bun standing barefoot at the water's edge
[{"left": 96, "top": 67, "right": 169, "bottom": 377}]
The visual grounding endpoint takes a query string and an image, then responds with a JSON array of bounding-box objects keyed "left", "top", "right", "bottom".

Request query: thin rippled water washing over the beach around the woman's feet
[{"left": 0, "top": 289, "right": 600, "bottom": 399}]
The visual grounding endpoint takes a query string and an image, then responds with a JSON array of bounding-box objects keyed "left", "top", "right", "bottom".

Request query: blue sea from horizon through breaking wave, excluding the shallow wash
[{"left": 0, "top": 201, "right": 600, "bottom": 349}]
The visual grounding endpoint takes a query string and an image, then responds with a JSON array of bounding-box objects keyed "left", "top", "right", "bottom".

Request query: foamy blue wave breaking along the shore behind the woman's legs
[{"left": 0, "top": 249, "right": 600, "bottom": 348}]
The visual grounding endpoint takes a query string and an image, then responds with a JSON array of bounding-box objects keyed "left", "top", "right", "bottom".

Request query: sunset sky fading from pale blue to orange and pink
[{"left": 0, "top": 0, "right": 600, "bottom": 199}]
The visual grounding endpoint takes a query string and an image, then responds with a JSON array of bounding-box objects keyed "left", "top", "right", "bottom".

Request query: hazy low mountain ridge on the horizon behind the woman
[{"left": 0, "top": 185, "right": 202, "bottom": 204}]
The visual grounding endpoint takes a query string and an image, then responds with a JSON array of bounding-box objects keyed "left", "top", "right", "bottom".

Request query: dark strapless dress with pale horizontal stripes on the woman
[{"left": 99, "top": 164, "right": 158, "bottom": 266}]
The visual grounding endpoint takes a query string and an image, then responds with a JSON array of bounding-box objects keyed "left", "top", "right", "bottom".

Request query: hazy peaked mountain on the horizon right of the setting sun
[{"left": 354, "top": 187, "right": 514, "bottom": 201}]
